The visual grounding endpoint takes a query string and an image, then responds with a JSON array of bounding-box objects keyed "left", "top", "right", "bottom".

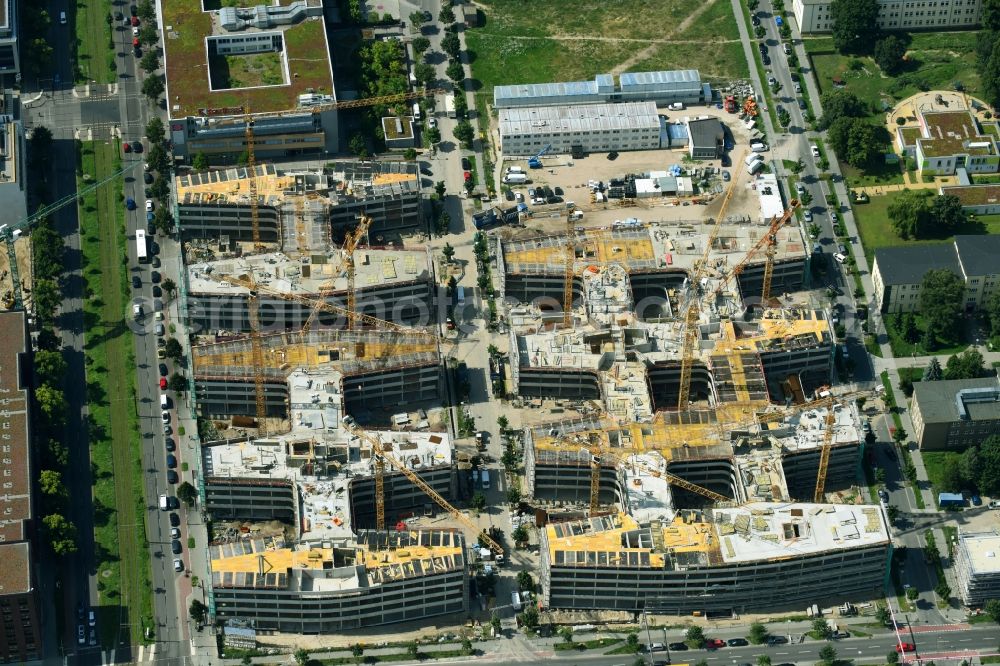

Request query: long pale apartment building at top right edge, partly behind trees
[{"left": 792, "top": 0, "right": 982, "bottom": 33}]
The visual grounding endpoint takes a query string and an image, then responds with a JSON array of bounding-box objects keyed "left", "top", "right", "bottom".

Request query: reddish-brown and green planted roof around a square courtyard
[{"left": 157, "top": 0, "right": 334, "bottom": 118}]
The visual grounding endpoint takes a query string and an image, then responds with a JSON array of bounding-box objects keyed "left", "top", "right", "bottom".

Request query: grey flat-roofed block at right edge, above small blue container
[{"left": 910, "top": 376, "right": 1000, "bottom": 448}]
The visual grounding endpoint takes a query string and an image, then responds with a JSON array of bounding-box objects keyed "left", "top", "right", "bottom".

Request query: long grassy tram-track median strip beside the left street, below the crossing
[{"left": 78, "top": 141, "right": 153, "bottom": 647}]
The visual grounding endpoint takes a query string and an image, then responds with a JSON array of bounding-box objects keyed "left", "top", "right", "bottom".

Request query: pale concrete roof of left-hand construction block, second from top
[{"left": 188, "top": 248, "right": 430, "bottom": 296}]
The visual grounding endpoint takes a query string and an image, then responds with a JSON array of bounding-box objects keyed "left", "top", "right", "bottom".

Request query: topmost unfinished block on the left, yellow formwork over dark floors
[{"left": 175, "top": 162, "right": 421, "bottom": 240}]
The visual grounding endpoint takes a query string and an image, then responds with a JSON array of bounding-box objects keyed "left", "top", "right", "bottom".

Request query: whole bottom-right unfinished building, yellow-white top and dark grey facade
[{"left": 539, "top": 504, "right": 892, "bottom": 616}]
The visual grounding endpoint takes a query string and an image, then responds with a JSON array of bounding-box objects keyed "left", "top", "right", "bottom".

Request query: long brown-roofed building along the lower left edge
[{"left": 0, "top": 311, "right": 42, "bottom": 664}]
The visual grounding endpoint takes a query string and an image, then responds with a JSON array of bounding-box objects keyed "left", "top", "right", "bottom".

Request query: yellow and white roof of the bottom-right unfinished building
[{"left": 544, "top": 502, "right": 889, "bottom": 569}]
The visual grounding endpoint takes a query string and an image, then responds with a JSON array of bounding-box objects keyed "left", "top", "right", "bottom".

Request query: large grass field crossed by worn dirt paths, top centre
[{"left": 465, "top": 0, "right": 747, "bottom": 93}]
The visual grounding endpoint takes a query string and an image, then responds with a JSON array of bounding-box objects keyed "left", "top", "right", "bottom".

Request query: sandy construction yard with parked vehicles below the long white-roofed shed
[{"left": 496, "top": 107, "right": 767, "bottom": 231}]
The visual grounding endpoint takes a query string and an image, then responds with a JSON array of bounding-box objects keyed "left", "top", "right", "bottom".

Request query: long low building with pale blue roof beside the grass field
[{"left": 493, "top": 69, "right": 712, "bottom": 109}]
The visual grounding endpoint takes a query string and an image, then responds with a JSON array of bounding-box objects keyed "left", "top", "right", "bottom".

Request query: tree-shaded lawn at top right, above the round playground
[{"left": 805, "top": 31, "right": 980, "bottom": 120}]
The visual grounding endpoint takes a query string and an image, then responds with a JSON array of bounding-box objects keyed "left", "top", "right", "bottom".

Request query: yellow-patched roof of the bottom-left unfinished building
[{"left": 209, "top": 531, "right": 465, "bottom": 592}]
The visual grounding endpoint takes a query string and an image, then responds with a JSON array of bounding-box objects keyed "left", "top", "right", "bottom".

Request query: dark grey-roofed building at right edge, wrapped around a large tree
[{"left": 872, "top": 234, "right": 1000, "bottom": 313}]
